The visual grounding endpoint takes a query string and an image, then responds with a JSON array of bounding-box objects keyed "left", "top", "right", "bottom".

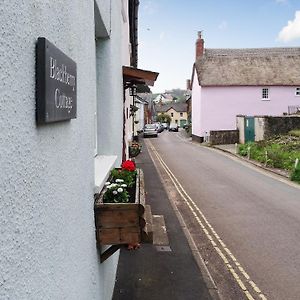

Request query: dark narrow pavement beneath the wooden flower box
[{"left": 113, "top": 137, "right": 216, "bottom": 300}]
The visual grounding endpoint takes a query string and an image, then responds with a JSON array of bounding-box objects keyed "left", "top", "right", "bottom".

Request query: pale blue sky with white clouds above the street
[{"left": 138, "top": 0, "right": 300, "bottom": 93}]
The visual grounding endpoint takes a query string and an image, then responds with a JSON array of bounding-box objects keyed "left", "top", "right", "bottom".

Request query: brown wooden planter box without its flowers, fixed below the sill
[{"left": 94, "top": 169, "right": 146, "bottom": 246}]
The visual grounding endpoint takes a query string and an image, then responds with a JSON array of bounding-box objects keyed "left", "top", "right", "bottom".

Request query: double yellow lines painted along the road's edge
[{"left": 145, "top": 140, "right": 267, "bottom": 300}]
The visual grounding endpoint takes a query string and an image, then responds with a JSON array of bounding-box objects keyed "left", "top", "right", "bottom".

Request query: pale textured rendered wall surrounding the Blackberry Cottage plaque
[{"left": 0, "top": 0, "right": 123, "bottom": 300}]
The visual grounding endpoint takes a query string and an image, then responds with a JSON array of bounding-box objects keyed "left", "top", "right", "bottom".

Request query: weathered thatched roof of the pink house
[{"left": 195, "top": 48, "right": 300, "bottom": 86}]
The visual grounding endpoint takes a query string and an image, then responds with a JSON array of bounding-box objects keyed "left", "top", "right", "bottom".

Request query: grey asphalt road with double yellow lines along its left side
[{"left": 146, "top": 132, "right": 300, "bottom": 300}]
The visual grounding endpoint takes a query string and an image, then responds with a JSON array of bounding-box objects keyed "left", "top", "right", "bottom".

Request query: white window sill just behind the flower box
[{"left": 94, "top": 155, "right": 118, "bottom": 194}]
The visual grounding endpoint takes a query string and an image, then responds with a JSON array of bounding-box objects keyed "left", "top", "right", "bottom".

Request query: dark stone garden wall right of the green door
[{"left": 264, "top": 116, "right": 300, "bottom": 139}]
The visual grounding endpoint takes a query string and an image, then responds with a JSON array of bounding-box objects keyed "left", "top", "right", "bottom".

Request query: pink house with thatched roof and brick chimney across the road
[{"left": 191, "top": 32, "right": 300, "bottom": 142}]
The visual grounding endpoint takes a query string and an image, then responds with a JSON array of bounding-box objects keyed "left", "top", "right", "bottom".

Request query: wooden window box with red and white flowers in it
[{"left": 94, "top": 160, "right": 146, "bottom": 246}]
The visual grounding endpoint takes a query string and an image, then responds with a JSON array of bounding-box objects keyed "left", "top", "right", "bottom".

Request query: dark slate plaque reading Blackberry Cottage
[{"left": 36, "top": 37, "right": 77, "bottom": 124}]
